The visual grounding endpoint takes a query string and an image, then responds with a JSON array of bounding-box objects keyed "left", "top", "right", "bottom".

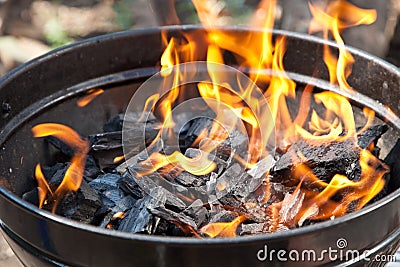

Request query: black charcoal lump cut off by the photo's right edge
[{"left": 384, "top": 139, "right": 400, "bottom": 193}]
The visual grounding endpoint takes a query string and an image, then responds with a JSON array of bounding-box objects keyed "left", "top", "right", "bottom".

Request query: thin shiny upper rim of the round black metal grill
[{"left": 0, "top": 25, "right": 400, "bottom": 245}]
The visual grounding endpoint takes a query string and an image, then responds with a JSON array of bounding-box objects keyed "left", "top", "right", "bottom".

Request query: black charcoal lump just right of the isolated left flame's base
[{"left": 57, "top": 180, "right": 101, "bottom": 223}]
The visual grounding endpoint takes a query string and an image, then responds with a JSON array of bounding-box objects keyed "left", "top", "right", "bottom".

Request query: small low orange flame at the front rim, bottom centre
[{"left": 200, "top": 215, "right": 246, "bottom": 238}]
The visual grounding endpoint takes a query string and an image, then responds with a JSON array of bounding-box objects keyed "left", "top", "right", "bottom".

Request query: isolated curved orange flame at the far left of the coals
[{"left": 32, "top": 123, "right": 89, "bottom": 213}]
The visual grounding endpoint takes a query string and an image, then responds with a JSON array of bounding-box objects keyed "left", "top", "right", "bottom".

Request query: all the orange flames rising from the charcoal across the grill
[{"left": 28, "top": 0, "right": 389, "bottom": 237}]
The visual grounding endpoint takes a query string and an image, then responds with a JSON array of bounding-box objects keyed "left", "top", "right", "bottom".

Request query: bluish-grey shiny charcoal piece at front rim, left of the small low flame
[{"left": 118, "top": 195, "right": 157, "bottom": 234}]
